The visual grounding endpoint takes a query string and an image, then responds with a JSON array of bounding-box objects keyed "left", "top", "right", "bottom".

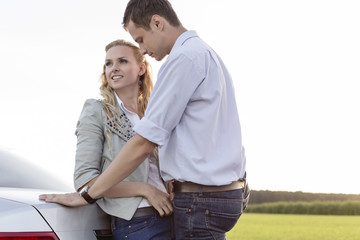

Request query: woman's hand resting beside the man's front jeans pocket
[{"left": 142, "top": 184, "right": 173, "bottom": 216}]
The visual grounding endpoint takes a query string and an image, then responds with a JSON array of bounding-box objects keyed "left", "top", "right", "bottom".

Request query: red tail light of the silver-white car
[{"left": 0, "top": 232, "right": 59, "bottom": 240}]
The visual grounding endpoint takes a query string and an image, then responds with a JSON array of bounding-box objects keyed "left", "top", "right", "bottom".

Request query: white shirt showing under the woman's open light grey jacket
[{"left": 115, "top": 94, "right": 167, "bottom": 208}]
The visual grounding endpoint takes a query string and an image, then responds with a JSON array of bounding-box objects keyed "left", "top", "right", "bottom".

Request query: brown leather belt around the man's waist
[{"left": 173, "top": 179, "right": 245, "bottom": 193}]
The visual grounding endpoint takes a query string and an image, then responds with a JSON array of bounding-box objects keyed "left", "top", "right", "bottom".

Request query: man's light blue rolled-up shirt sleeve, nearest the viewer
[{"left": 134, "top": 54, "right": 204, "bottom": 146}]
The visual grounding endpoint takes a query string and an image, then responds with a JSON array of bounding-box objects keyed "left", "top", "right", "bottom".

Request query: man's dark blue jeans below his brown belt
[{"left": 174, "top": 185, "right": 250, "bottom": 240}]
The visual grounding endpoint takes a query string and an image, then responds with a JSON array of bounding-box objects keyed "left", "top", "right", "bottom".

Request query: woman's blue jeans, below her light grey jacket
[{"left": 112, "top": 212, "right": 171, "bottom": 240}]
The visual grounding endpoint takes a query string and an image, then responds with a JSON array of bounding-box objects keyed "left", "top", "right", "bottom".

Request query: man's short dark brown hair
[{"left": 123, "top": 0, "right": 181, "bottom": 30}]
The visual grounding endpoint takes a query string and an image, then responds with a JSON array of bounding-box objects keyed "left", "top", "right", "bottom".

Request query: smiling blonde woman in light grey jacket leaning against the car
[{"left": 40, "top": 40, "right": 172, "bottom": 239}]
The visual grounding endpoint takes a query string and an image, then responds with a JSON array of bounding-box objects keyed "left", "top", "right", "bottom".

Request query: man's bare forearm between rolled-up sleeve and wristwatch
[{"left": 88, "top": 134, "right": 155, "bottom": 198}]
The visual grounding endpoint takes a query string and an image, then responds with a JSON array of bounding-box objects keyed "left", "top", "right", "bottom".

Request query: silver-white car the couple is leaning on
[{"left": 0, "top": 150, "right": 112, "bottom": 240}]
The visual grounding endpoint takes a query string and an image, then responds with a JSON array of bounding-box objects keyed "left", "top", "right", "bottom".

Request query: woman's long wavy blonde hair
[{"left": 100, "top": 40, "right": 154, "bottom": 141}]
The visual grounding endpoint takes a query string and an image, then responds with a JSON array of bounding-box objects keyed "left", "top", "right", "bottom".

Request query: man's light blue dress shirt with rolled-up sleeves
[{"left": 134, "top": 31, "right": 246, "bottom": 185}]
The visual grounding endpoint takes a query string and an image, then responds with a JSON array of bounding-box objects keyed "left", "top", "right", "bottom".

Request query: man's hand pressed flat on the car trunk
[{"left": 39, "top": 192, "right": 88, "bottom": 207}]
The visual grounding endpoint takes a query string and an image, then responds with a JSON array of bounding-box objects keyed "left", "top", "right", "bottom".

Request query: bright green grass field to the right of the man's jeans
[{"left": 227, "top": 213, "right": 360, "bottom": 240}]
